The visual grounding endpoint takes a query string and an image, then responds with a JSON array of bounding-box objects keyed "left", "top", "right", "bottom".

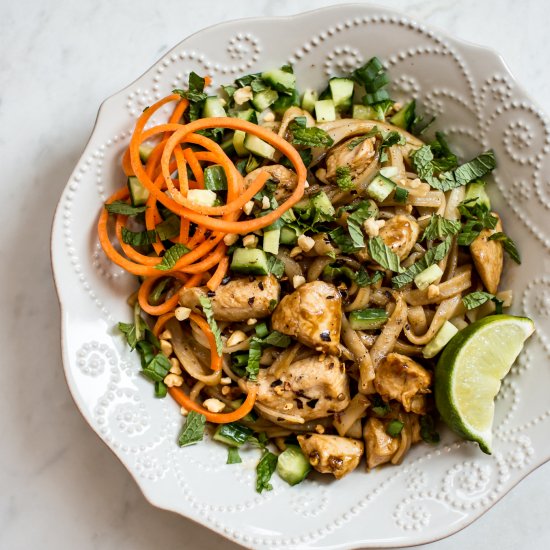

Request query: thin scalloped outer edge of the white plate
[{"left": 50, "top": 2, "right": 550, "bottom": 550}]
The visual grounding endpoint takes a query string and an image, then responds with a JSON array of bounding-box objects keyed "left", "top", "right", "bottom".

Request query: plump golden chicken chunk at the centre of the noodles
[{"left": 271, "top": 281, "right": 342, "bottom": 355}]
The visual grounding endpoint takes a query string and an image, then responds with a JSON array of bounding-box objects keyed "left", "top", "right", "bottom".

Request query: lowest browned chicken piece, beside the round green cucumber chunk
[{"left": 298, "top": 434, "right": 363, "bottom": 479}]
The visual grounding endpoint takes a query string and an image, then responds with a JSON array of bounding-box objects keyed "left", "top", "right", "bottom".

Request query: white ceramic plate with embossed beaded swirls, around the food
[{"left": 52, "top": 5, "right": 550, "bottom": 549}]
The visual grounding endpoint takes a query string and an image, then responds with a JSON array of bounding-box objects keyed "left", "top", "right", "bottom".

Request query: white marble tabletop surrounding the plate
[{"left": 0, "top": 0, "right": 550, "bottom": 550}]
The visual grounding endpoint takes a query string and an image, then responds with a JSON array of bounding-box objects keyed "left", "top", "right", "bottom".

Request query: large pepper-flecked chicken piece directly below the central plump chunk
[{"left": 257, "top": 355, "right": 350, "bottom": 422}]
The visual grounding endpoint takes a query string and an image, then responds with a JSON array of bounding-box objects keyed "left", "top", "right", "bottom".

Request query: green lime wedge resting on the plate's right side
[{"left": 435, "top": 315, "right": 535, "bottom": 454}]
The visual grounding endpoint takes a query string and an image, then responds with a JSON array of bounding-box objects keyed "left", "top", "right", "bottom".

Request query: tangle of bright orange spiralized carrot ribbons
[{"left": 98, "top": 89, "right": 307, "bottom": 424}]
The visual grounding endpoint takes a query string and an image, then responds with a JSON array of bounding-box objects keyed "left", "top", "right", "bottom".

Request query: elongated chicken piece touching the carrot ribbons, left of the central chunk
[{"left": 179, "top": 275, "right": 280, "bottom": 321}]
